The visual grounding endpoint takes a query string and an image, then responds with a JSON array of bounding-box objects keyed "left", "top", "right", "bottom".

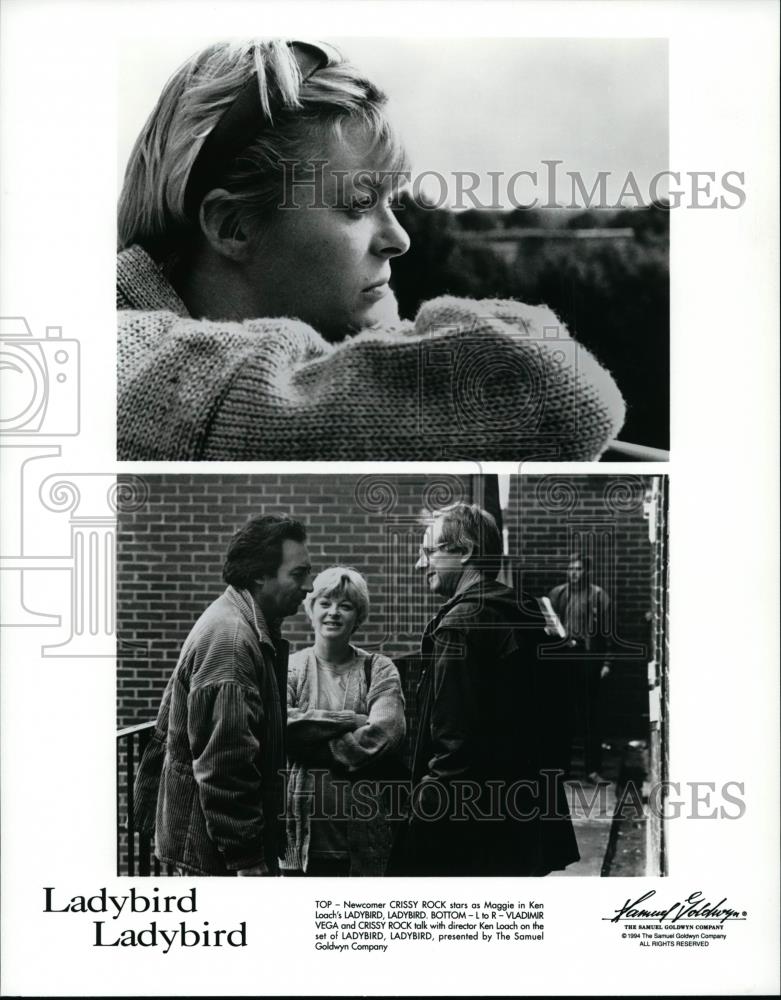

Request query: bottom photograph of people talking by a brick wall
[{"left": 116, "top": 474, "right": 668, "bottom": 877}]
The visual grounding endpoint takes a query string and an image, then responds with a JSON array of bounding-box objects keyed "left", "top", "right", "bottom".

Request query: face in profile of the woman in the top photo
[{"left": 249, "top": 125, "right": 409, "bottom": 340}]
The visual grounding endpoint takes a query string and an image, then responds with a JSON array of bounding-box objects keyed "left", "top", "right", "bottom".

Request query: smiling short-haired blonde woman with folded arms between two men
[{"left": 284, "top": 566, "right": 405, "bottom": 876}]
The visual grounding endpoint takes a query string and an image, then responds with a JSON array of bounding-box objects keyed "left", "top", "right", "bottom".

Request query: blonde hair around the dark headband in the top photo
[{"left": 118, "top": 40, "right": 406, "bottom": 260}]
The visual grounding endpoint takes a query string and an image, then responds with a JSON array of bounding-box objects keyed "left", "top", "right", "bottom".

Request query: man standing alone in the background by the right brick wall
[{"left": 548, "top": 555, "right": 611, "bottom": 784}]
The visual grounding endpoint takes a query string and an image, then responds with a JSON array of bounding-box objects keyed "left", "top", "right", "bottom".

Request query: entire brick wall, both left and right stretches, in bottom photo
[{"left": 117, "top": 474, "right": 652, "bottom": 735}]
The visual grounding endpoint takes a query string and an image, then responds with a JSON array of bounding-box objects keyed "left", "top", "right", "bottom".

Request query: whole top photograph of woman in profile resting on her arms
[{"left": 117, "top": 31, "right": 675, "bottom": 463}]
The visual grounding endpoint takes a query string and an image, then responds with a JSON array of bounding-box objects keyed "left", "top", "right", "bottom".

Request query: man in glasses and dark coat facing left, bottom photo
[{"left": 393, "top": 503, "right": 579, "bottom": 876}]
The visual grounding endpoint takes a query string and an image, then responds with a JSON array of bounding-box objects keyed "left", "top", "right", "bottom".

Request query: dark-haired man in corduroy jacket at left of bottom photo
[{"left": 134, "top": 515, "right": 312, "bottom": 875}]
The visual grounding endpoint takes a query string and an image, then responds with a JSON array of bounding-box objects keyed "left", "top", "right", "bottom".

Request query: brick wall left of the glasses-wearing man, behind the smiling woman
[{"left": 117, "top": 475, "right": 472, "bottom": 727}]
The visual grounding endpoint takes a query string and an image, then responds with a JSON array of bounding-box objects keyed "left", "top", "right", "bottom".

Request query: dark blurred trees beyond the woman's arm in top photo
[{"left": 391, "top": 199, "right": 670, "bottom": 449}]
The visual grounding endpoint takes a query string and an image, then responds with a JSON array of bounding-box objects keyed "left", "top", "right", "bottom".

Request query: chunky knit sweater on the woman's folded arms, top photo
[{"left": 117, "top": 247, "right": 624, "bottom": 461}]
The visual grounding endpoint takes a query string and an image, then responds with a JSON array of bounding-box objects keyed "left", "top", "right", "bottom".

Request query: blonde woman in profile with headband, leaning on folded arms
[{"left": 117, "top": 41, "right": 624, "bottom": 460}]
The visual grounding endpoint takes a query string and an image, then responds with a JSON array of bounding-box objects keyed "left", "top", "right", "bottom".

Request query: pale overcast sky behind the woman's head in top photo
[{"left": 119, "top": 36, "right": 668, "bottom": 207}]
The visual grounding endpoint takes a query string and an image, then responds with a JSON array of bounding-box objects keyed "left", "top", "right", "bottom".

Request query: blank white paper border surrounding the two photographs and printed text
[{"left": 0, "top": 0, "right": 779, "bottom": 995}]
